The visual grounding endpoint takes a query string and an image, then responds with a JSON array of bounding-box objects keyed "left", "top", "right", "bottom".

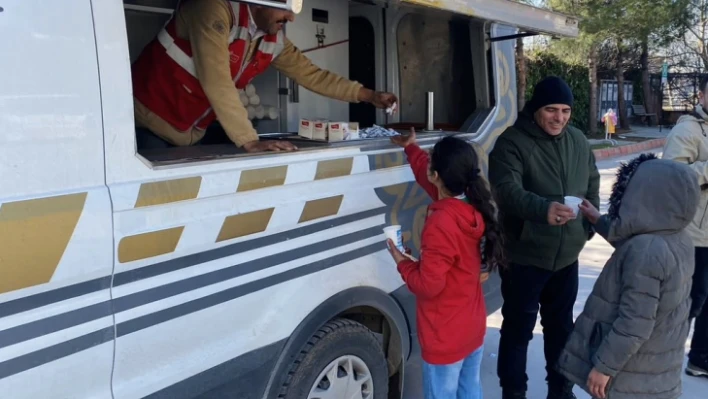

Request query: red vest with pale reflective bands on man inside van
[{"left": 132, "top": 1, "right": 284, "bottom": 132}]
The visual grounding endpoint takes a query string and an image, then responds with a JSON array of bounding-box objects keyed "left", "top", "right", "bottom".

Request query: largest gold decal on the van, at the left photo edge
[{"left": 0, "top": 193, "right": 87, "bottom": 294}]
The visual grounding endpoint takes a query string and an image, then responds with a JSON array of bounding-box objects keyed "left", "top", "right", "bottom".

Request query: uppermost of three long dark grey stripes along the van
[{"left": 0, "top": 207, "right": 386, "bottom": 318}]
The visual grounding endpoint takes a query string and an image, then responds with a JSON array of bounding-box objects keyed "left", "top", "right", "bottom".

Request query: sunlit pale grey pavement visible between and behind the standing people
[{"left": 482, "top": 152, "right": 708, "bottom": 399}]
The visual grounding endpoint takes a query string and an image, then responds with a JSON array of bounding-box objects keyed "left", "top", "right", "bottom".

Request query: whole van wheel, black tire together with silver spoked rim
[{"left": 278, "top": 319, "right": 388, "bottom": 399}]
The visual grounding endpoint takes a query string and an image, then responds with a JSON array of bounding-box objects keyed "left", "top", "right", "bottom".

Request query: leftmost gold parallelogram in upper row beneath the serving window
[{"left": 135, "top": 176, "right": 202, "bottom": 208}]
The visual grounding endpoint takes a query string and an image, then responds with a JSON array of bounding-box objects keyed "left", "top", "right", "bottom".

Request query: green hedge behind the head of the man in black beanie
[{"left": 526, "top": 53, "right": 590, "bottom": 134}]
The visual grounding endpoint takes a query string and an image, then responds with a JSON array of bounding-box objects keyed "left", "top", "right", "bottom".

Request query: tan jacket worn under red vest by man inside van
[{"left": 134, "top": 0, "right": 362, "bottom": 147}]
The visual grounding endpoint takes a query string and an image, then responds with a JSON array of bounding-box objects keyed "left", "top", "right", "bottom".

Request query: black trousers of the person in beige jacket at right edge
[{"left": 688, "top": 247, "right": 708, "bottom": 362}]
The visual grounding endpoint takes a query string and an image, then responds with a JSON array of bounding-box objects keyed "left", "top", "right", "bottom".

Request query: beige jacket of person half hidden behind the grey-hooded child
[{"left": 662, "top": 109, "right": 708, "bottom": 247}]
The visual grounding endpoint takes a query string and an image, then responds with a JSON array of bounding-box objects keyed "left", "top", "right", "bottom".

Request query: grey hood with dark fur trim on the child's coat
[{"left": 607, "top": 154, "right": 699, "bottom": 242}]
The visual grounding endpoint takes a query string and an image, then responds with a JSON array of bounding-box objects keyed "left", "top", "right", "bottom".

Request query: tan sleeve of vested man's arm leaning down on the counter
[{"left": 179, "top": 0, "right": 258, "bottom": 147}]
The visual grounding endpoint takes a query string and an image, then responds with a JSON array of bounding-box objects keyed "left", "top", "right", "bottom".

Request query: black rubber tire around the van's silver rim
[{"left": 278, "top": 319, "right": 388, "bottom": 399}]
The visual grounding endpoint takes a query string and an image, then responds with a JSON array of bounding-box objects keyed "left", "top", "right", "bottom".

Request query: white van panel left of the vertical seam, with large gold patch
[{"left": 0, "top": 0, "right": 113, "bottom": 399}]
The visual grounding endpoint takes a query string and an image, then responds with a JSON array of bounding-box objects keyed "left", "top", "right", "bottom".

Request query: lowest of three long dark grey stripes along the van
[{"left": 0, "top": 243, "right": 386, "bottom": 379}]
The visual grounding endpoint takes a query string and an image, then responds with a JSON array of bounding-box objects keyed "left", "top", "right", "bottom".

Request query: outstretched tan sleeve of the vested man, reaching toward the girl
[{"left": 272, "top": 38, "right": 363, "bottom": 103}]
